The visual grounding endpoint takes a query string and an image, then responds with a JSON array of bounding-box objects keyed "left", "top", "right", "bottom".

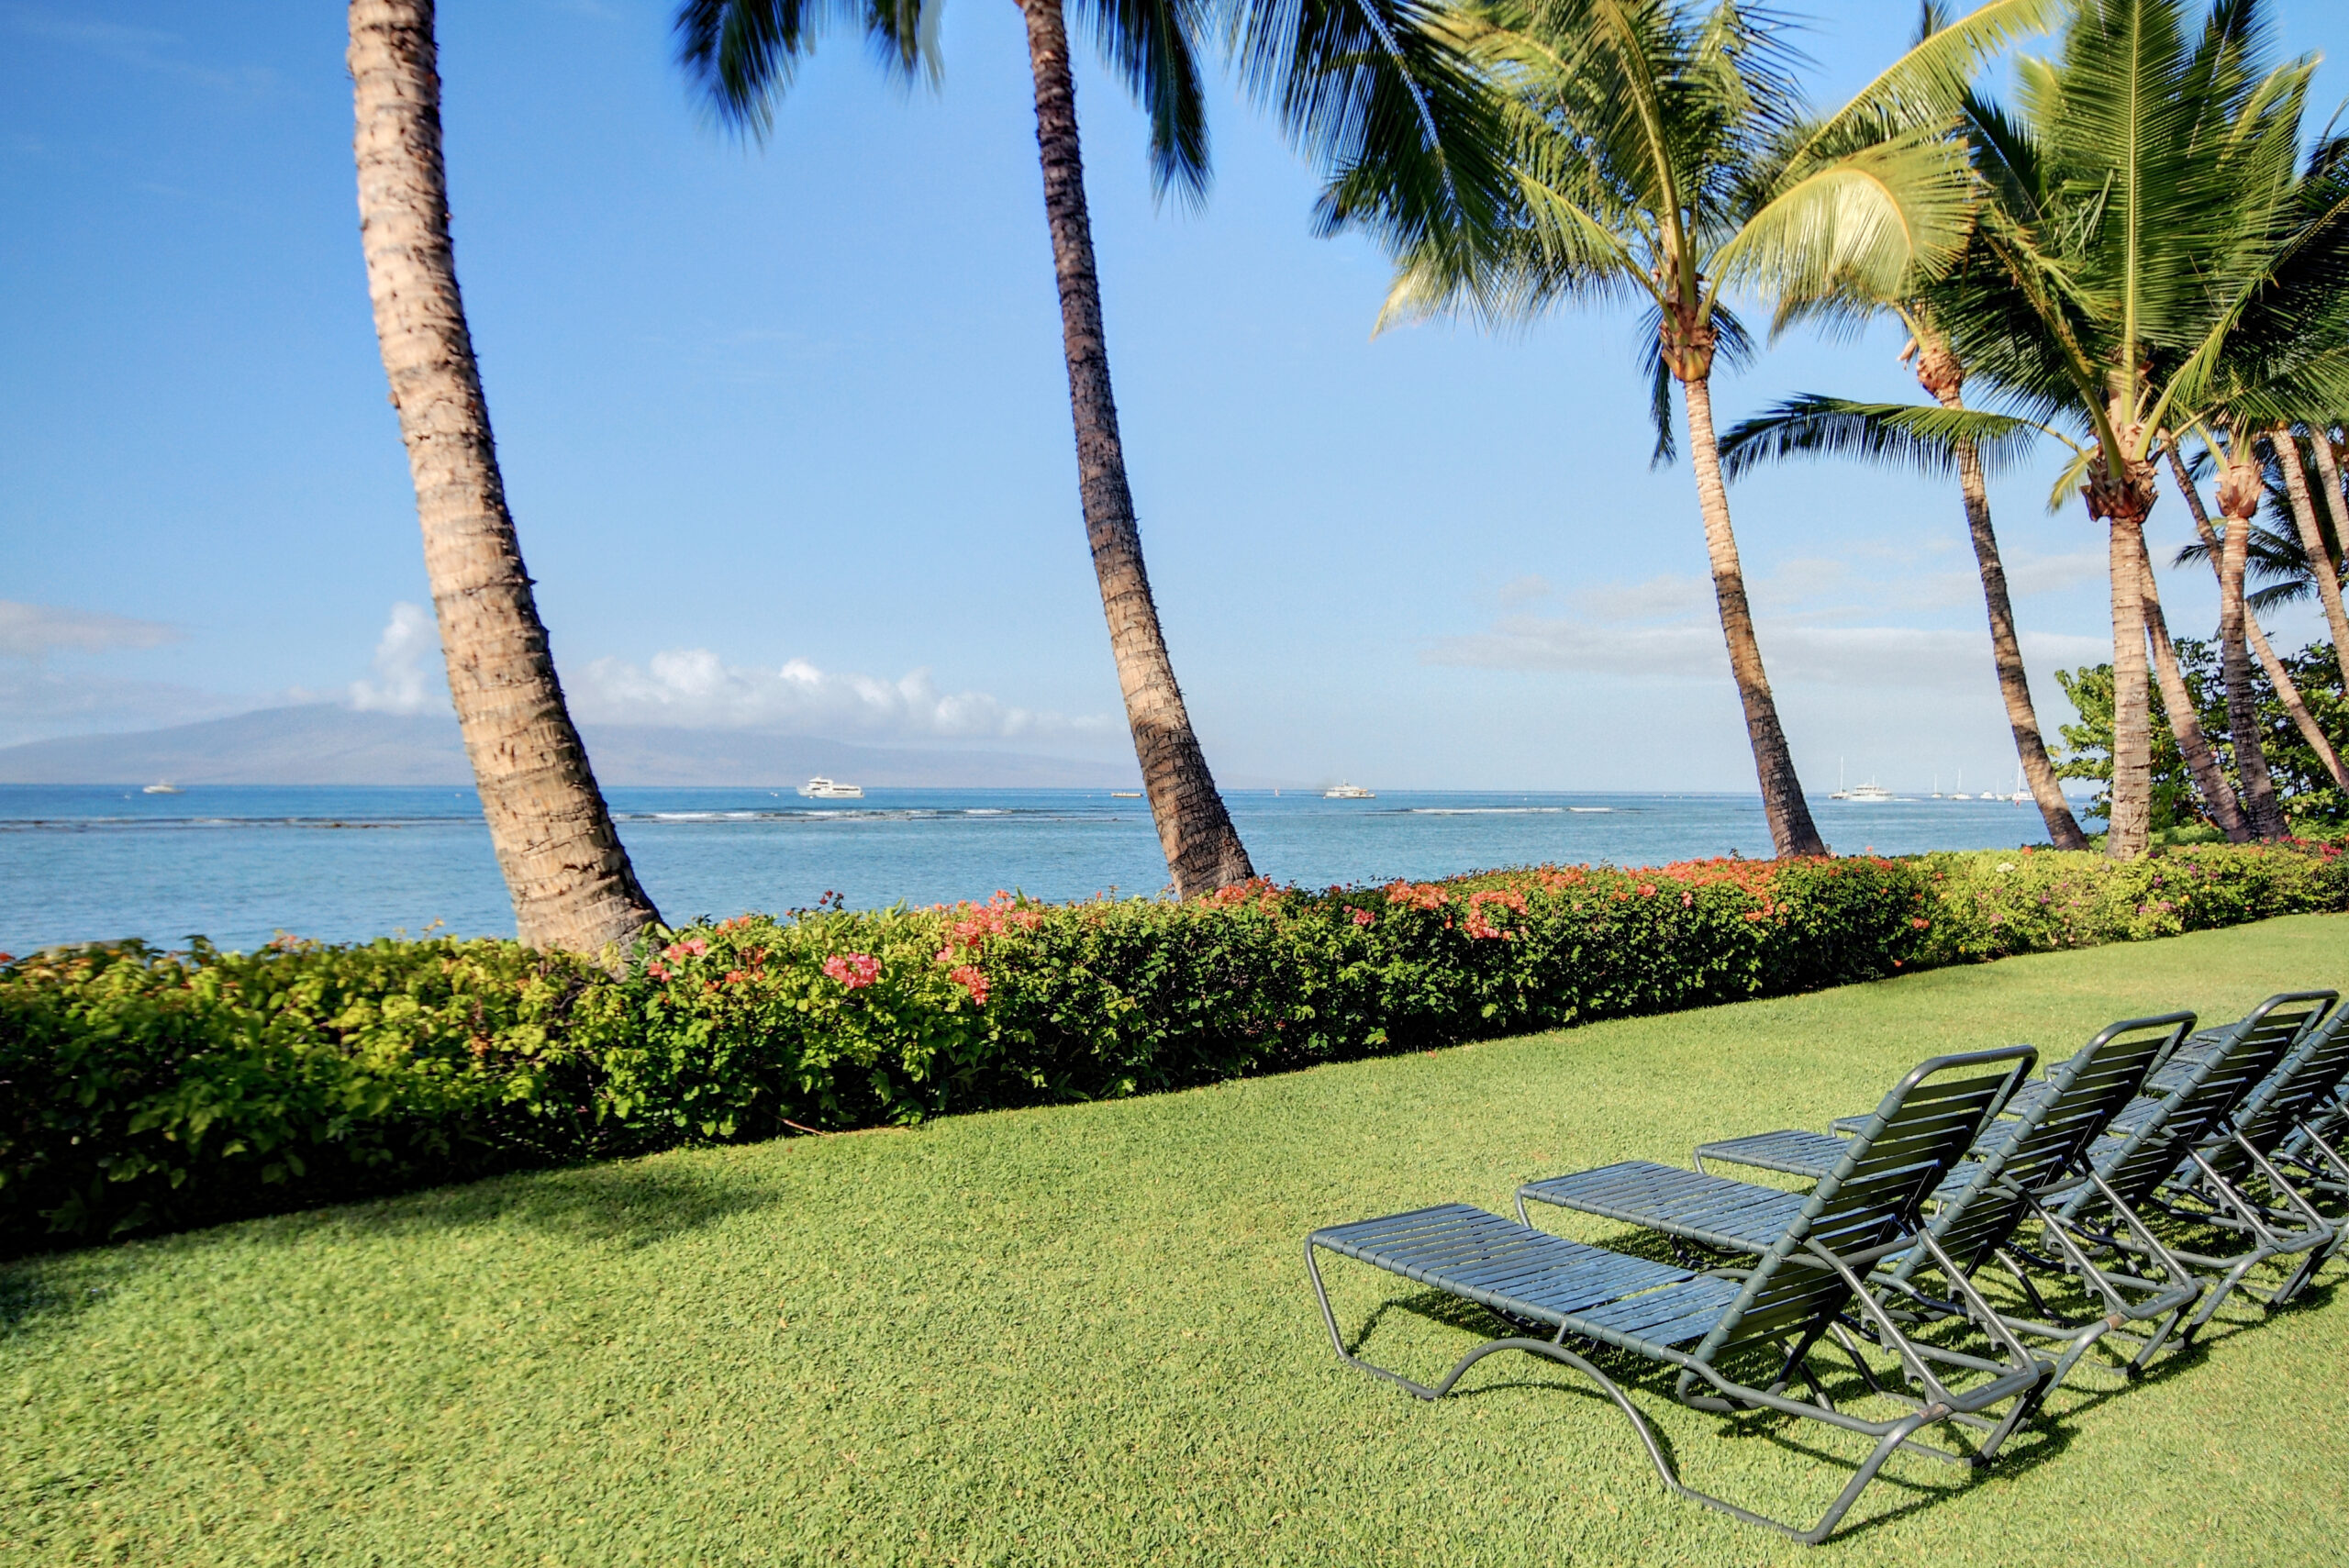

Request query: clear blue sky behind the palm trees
[{"left": 0, "top": 0, "right": 2349, "bottom": 789}]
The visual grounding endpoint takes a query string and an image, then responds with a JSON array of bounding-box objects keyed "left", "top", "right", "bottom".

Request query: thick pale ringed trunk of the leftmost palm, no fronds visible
[{"left": 350, "top": 0, "right": 660, "bottom": 960}]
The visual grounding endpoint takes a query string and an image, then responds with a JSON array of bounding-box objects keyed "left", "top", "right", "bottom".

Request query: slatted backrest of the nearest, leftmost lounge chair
[{"left": 1696, "top": 1044, "right": 2039, "bottom": 1362}]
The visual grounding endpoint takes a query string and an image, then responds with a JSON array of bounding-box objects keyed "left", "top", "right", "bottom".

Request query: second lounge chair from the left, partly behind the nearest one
[{"left": 1518, "top": 1012, "right": 2201, "bottom": 1392}]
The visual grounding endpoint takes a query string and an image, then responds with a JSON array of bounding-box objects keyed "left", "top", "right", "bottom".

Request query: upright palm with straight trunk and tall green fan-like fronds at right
[{"left": 1869, "top": 0, "right": 2311, "bottom": 859}]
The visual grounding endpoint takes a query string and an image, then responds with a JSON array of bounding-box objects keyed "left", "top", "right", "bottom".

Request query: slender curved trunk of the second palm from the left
[{"left": 1019, "top": 0, "right": 1254, "bottom": 899}]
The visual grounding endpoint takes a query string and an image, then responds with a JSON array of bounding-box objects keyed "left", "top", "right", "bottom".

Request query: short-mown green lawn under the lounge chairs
[{"left": 14, "top": 916, "right": 2349, "bottom": 1565}]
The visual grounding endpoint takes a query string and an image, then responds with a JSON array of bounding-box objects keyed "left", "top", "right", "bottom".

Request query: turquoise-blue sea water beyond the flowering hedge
[{"left": 0, "top": 784, "right": 2086, "bottom": 953}]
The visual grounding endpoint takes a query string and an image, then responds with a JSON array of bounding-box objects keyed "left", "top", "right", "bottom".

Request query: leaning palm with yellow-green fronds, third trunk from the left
[{"left": 1337, "top": 0, "right": 2060, "bottom": 854}]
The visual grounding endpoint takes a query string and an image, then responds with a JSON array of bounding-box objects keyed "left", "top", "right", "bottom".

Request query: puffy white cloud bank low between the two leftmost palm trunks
[{"left": 563, "top": 648, "right": 1123, "bottom": 741}]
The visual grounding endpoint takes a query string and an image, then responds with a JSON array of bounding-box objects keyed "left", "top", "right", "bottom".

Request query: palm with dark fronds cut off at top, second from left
[{"left": 676, "top": 0, "right": 1497, "bottom": 896}]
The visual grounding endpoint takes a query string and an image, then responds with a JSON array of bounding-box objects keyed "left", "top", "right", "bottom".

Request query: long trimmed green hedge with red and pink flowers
[{"left": 0, "top": 845, "right": 2349, "bottom": 1251}]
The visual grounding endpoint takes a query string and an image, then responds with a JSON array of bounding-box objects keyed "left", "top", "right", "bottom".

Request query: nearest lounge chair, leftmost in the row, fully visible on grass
[{"left": 1306, "top": 1044, "right": 2053, "bottom": 1542}]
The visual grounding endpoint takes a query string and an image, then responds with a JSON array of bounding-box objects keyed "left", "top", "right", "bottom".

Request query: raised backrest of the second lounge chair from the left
[{"left": 1920, "top": 1012, "right": 2194, "bottom": 1270}]
